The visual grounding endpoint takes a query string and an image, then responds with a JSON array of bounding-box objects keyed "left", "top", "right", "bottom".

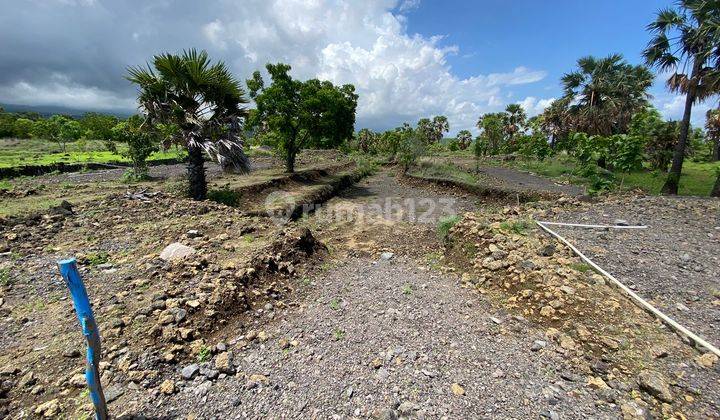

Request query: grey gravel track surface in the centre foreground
[{"left": 135, "top": 259, "right": 615, "bottom": 418}]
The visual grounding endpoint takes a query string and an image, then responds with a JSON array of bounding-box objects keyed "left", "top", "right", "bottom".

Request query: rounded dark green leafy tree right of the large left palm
[{"left": 247, "top": 63, "right": 358, "bottom": 172}]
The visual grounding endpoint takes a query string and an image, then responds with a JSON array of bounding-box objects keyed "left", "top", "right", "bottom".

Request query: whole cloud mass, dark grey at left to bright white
[{"left": 0, "top": 0, "right": 546, "bottom": 130}]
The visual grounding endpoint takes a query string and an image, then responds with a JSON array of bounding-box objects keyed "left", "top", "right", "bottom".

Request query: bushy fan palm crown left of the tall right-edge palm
[{"left": 562, "top": 54, "right": 653, "bottom": 135}]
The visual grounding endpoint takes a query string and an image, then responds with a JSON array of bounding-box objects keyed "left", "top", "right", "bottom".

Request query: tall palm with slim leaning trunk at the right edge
[{"left": 643, "top": 0, "right": 720, "bottom": 194}]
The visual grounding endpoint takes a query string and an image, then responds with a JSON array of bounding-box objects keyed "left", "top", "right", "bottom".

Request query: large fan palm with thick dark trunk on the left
[{"left": 127, "top": 49, "right": 250, "bottom": 200}]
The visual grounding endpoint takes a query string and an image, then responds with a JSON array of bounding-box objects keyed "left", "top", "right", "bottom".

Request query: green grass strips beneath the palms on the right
[{"left": 496, "top": 155, "right": 720, "bottom": 196}]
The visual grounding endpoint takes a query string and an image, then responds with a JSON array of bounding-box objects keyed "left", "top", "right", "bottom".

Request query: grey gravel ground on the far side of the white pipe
[{"left": 551, "top": 197, "right": 720, "bottom": 346}]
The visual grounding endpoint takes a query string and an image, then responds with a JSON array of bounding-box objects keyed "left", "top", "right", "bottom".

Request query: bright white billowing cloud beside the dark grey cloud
[{"left": 205, "top": 0, "right": 546, "bottom": 130}]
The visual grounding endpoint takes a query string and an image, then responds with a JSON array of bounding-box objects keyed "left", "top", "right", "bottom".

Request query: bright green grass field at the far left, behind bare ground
[{"left": 0, "top": 139, "right": 184, "bottom": 168}]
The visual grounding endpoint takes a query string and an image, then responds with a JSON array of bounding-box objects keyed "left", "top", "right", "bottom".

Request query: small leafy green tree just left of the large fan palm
[{"left": 110, "top": 115, "right": 161, "bottom": 180}]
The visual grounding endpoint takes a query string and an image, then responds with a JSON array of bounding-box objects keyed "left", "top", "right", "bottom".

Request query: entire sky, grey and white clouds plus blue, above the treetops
[{"left": 0, "top": 0, "right": 716, "bottom": 135}]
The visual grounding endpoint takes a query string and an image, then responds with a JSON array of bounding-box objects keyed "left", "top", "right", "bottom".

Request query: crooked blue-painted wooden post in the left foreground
[{"left": 58, "top": 258, "right": 107, "bottom": 420}]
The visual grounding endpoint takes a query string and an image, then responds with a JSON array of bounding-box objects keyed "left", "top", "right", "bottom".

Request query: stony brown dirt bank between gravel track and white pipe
[{"left": 446, "top": 209, "right": 720, "bottom": 416}]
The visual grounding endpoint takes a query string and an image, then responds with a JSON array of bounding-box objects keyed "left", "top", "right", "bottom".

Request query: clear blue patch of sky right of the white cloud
[{"left": 406, "top": 0, "right": 692, "bottom": 117}]
